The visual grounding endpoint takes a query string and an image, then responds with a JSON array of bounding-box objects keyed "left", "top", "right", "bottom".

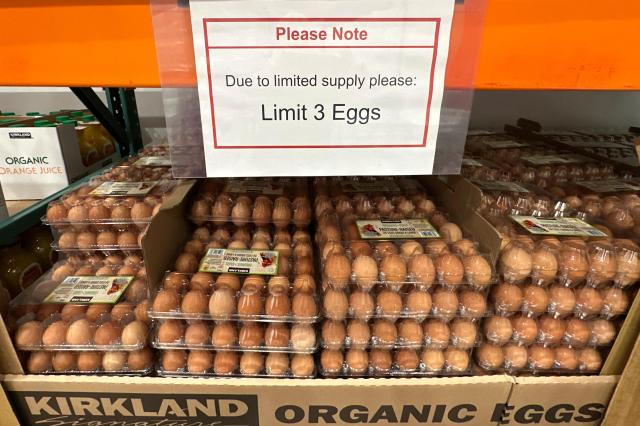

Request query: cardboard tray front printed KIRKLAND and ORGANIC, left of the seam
[{"left": 4, "top": 376, "right": 512, "bottom": 426}]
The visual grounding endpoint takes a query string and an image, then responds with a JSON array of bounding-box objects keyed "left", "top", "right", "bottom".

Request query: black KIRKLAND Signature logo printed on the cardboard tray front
[{"left": 8, "top": 391, "right": 259, "bottom": 426}]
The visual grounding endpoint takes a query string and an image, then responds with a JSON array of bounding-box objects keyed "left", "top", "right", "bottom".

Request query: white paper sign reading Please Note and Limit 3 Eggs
[{"left": 190, "top": 0, "right": 454, "bottom": 176}]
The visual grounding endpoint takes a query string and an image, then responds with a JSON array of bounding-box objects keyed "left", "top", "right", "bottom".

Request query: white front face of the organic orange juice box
[{"left": 0, "top": 127, "right": 69, "bottom": 200}]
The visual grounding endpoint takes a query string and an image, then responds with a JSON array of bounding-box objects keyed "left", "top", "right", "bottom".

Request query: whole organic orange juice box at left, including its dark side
[{"left": 0, "top": 118, "right": 120, "bottom": 200}]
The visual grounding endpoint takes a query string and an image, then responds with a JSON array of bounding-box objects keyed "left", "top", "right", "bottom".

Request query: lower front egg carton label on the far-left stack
[{"left": 43, "top": 276, "right": 133, "bottom": 304}]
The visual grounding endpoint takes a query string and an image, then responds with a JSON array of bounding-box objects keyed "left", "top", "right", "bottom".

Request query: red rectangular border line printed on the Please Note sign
[{"left": 202, "top": 18, "right": 440, "bottom": 149}]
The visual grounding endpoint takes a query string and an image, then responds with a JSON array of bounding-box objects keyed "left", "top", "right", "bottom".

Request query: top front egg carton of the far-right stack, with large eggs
[{"left": 498, "top": 240, "right": 640, "bottom": 288}]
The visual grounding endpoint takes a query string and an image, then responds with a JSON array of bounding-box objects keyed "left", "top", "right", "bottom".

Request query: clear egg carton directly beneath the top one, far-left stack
[{"left": 51, "top": 224, "right": 149, "bottom": 255}]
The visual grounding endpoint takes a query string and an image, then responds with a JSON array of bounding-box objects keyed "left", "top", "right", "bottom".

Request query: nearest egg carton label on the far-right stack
[{"left": 511, "top": 215, "right": 607, "bottom": 237}]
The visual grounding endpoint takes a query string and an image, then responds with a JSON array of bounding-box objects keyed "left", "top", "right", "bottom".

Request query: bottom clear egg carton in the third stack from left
[{"left": 318, "top": 348, "right": 473, "bottom": 377}]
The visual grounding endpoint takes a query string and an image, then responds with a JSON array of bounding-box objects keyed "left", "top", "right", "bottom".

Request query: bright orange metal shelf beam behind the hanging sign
[{"left": 0, "top": 0, "right": 640, "bottom": 90}]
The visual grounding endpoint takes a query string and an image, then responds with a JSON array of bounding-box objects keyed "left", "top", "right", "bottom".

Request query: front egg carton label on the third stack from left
[{"left": 356, "top": 219, "right": 440, "bottom": 240}]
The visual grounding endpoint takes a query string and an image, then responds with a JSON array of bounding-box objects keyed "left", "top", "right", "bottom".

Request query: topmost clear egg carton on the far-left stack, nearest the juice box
[{"left": 42, "top": 181, "right": 176, "bottom": 230}]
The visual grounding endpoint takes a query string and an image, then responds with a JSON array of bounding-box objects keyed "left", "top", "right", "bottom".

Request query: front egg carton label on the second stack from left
[{"left": 199, "top": 248, "right": 278, "bottom": 275}]
